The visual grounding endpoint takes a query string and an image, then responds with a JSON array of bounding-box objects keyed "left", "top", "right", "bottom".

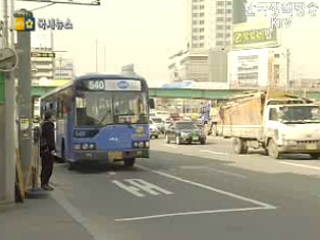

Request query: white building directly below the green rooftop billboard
[{"left": 228, "top": 47, "right": 288, "bottom": 89}]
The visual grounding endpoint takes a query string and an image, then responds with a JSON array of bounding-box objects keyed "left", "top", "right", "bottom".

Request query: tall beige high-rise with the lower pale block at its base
[{"left": 169, "top": 0, "right": 246, "bottom": 82}]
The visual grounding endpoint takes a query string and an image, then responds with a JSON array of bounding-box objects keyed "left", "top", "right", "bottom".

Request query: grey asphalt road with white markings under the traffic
[{"left": 52, "top": 138, "right": 320, "bottom": 240}]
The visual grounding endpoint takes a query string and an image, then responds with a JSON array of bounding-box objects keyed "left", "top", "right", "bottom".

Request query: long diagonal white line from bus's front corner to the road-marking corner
[{"left": 137, "top": 165, "right": 277, "bottom": 209}]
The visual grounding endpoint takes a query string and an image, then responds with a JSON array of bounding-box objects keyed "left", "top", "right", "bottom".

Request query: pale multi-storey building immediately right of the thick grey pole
[{"left": 31, "top": 49, "right": 56, "bottom": 85}]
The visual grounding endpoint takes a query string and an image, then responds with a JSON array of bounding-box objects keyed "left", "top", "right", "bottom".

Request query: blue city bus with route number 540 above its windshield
[{"left": 41, "top": 74, "right": 150, "bottom": 170}]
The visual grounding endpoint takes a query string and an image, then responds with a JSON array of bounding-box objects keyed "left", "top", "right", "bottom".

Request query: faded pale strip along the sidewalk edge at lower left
[{"left": 50, "top": 189, "right": 108, "bottom": 240}]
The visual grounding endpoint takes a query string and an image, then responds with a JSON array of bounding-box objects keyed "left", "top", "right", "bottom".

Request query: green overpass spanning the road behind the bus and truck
[{"left": 32, "top": 86, "right": 320, "bottom": 101}]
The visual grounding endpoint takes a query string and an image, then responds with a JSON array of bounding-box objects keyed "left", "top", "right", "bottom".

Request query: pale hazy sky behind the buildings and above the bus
[{"left": 16, "top": 0, "right": 320, "bottom": 83}]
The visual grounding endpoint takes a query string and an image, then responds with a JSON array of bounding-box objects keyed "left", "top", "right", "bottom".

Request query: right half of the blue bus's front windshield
[{"left": 113, "top": 92, "right": 148, "bottom": 123}]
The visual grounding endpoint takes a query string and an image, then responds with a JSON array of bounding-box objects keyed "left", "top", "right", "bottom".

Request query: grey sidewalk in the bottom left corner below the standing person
[{"left": 0, "top": 193, "right": 93, "bottom": 240}]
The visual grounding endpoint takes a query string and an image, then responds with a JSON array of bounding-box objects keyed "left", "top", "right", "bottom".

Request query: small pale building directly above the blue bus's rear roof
[{"left": 54, "top": 57, "right": 74, "bottom": 80}]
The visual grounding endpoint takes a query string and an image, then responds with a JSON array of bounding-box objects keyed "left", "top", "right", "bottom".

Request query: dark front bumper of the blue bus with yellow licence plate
[{"left": 74, "top": 148, "right": 149, "bottom": 162}]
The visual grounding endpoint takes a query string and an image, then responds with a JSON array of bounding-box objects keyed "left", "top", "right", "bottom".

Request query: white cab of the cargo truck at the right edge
[{"left": 260, "top": 100, "right": 320, "bottom": 159}]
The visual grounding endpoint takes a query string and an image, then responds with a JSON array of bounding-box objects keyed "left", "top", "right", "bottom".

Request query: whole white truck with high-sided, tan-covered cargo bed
[{"left": 218, "top": 92, "right": 320, "bottom": 159}]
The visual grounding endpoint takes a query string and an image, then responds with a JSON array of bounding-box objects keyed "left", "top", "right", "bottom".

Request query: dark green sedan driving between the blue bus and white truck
[{"left": 165, "top": 121, "right": 206, "bottom": 145}]
